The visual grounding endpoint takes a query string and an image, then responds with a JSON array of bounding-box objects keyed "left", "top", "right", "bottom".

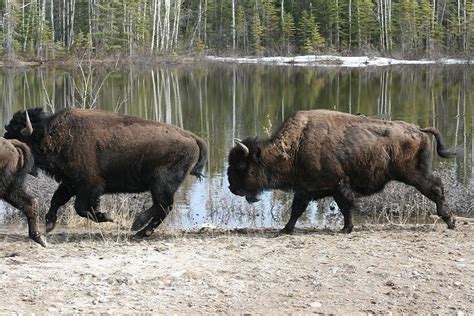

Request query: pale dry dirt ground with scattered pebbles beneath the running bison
[{"left": 0, "top": 223, "right": 474, "bottom": 314}]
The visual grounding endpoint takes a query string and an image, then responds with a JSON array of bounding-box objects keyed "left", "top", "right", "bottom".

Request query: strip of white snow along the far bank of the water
[{"left": 207, "top": 55, "right": 474, "bottom": 67}]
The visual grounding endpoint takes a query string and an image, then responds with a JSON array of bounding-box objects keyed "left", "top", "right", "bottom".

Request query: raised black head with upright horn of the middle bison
[{"left": 4, "top": 108, "right": 43, "bottom": 144}]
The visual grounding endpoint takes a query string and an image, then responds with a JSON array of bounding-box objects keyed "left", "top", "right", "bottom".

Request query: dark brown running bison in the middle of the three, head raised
[{"left": 5, "top": 108, "right": 207, "bottom": 237}]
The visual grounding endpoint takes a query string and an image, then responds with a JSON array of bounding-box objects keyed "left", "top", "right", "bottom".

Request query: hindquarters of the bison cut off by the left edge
[{"left": 0, "top": 137, "right": 46, "bottom": 247}]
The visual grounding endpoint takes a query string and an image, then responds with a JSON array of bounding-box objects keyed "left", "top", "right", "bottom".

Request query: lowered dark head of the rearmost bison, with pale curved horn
[{"left": 227, "top": 138, "right": 268, "bottom": 203}]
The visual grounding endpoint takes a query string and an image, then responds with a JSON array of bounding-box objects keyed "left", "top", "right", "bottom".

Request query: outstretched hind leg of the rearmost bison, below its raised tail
[{"left": 412, "top": 174, "right": 456, "bottom": 229}]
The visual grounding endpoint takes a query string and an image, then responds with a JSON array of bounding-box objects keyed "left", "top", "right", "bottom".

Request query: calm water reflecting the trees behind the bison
[{"left": 0, "top": 64, "right": 474, "bottom": 227}]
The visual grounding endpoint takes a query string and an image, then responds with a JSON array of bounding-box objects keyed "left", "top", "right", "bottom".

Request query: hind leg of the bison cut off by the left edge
[{"left": 5, "top": 188, "right": 46, "bottom": 247}]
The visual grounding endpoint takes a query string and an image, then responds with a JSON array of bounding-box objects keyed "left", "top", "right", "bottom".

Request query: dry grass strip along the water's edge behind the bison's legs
[{"left": 1, "top": 166, "right": 474, "bottom": 233}]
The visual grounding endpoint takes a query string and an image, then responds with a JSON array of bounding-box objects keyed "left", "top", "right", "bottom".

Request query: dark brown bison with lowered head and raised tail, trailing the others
[{"left": 227, "top": 110, "right": 458, "bottom": 234}]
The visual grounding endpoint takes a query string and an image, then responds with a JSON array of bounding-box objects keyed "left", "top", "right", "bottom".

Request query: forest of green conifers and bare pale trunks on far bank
[{"left": 0, "top": 0, "right": 474, "bottom": 61}]
